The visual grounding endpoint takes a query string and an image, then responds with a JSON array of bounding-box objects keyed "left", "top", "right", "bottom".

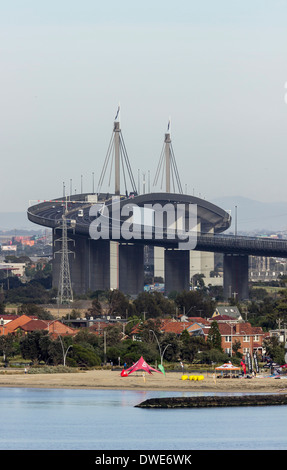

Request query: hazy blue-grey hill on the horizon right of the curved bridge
[{"left": 211, "top": 196, "right": 287, "bottom": 233}]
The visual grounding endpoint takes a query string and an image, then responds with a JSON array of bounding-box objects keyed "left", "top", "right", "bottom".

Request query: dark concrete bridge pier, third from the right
[{"left": 118, "top": 243, "right": 144, "bottom": 295}]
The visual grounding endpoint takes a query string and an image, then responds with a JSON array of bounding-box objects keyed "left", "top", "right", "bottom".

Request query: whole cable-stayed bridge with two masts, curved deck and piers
[{"left": 28, "top": 111, "right": 287, "bottom": 303}]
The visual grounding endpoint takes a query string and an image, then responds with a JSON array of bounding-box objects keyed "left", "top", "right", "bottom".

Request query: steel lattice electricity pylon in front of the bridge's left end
[{"left": 55, "top": 212, "right": 75, "bottom": 304}]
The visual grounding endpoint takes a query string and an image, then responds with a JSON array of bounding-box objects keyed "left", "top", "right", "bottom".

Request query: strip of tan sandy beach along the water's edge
[{"left": 0, "top": 370, "right": 287, "bottom": 393}]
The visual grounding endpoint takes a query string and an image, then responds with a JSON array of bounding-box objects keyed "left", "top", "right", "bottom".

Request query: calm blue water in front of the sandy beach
[{"left": 0, "top": 388, "right": 287, "bottom": 451}]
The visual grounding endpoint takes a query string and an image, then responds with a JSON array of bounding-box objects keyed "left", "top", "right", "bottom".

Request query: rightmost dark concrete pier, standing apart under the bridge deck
[{"left": 223, "top": 254, "right": 249, "bottom": 300}]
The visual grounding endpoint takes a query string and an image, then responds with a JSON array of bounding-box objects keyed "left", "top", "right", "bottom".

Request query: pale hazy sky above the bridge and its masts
[{"left": 0, "top": 0, "right": 287, "bottom": 212}]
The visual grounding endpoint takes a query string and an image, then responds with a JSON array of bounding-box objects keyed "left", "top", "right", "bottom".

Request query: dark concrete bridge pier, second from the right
[{"left": 164, "top": 249, "right": 190, "bottom": 294}]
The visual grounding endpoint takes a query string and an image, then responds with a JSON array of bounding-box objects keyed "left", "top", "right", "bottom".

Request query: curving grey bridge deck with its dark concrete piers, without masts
[{"left": 28, "top": 193, "right": 287, "bottom": 299}]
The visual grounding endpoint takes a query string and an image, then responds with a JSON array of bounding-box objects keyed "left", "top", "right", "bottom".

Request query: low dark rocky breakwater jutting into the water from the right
[{"left": 136, "top": 393, "right": 287, "bottom": 408}]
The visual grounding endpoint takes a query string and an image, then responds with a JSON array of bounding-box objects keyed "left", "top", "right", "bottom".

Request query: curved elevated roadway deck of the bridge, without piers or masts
[{"left": 27, "top": 193, "right": 287, "bottom": 258}]
